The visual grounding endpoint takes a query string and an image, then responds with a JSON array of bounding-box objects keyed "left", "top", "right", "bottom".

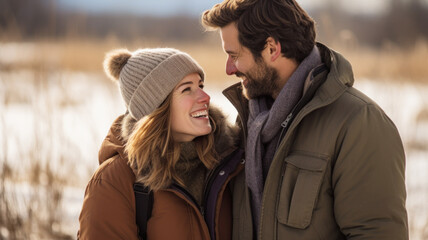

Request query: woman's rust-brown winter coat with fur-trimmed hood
[{"left": 78, "top": 109, "right": 243, "bottom": 240}]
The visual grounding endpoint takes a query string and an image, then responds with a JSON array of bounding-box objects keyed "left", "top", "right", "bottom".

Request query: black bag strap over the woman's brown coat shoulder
[{"left": 134, "top": 183, "right": 153, "bottom": 240}]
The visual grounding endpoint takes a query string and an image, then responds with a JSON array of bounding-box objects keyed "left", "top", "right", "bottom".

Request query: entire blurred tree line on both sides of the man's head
[{"left": 0, "top": 0, "right": 428, "bottom": 46}]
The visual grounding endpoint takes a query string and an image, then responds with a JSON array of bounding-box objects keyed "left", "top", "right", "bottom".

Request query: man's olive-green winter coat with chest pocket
[{"left": 224, "top": 44, "right": 408, "bottom": 240}]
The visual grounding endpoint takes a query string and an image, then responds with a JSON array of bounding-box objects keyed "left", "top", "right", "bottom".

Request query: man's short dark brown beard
[{"left": 235, "top": 59, "right": 278, "bottom": 99}]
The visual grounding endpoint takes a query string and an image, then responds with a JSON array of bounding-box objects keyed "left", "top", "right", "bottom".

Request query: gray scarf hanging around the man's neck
[{"left": 245, "top": 46, "right": 321, "bottom": 232}]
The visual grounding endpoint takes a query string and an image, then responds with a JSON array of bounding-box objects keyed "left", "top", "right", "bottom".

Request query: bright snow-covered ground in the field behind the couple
[{"left": 0, "top": 70, "right": 428, "bottom": 240}]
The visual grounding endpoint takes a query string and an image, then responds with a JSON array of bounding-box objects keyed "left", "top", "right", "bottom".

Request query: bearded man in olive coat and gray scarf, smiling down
[{"left": 202, "top": 0, "right": 408, "bottom": 240}]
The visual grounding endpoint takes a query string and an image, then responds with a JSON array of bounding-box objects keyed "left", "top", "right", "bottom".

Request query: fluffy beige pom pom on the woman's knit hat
[{"left": 103, "top": 49, "right": 132, "bottom": 81}]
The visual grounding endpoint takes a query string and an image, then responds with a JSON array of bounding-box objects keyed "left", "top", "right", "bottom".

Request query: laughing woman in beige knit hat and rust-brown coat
[{"left": 78, "top": 48, "right": 243, "bottom": 240}]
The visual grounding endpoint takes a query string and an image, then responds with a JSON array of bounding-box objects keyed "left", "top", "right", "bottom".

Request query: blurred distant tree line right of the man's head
[{"left": 311, "top": 0, "right": 428, "bottom": 47}]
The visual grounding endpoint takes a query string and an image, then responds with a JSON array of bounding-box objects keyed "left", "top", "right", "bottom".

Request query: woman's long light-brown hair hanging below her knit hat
[{"left": 125, "top": 93, "right": 217, "bottom": 190}]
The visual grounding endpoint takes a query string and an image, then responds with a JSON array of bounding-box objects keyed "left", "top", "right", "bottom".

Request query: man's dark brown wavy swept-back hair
[{"left": 202, "top": 0, "right": 316, "bottom": 63}]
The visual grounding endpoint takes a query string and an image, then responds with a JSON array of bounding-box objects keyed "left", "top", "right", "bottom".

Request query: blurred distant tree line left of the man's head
[{"left": 0, "top": 0, "right": 207, "bottom": 41}]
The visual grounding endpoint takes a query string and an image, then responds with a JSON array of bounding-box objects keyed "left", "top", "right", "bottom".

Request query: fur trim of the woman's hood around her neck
[{"left": 98, "top": 105, "right": 239, "bottom": 169}]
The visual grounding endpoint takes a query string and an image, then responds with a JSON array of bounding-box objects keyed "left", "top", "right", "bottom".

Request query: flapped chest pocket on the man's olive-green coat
[{"left": 277, "top": 155, "right": 328, "bottom": 229}]
